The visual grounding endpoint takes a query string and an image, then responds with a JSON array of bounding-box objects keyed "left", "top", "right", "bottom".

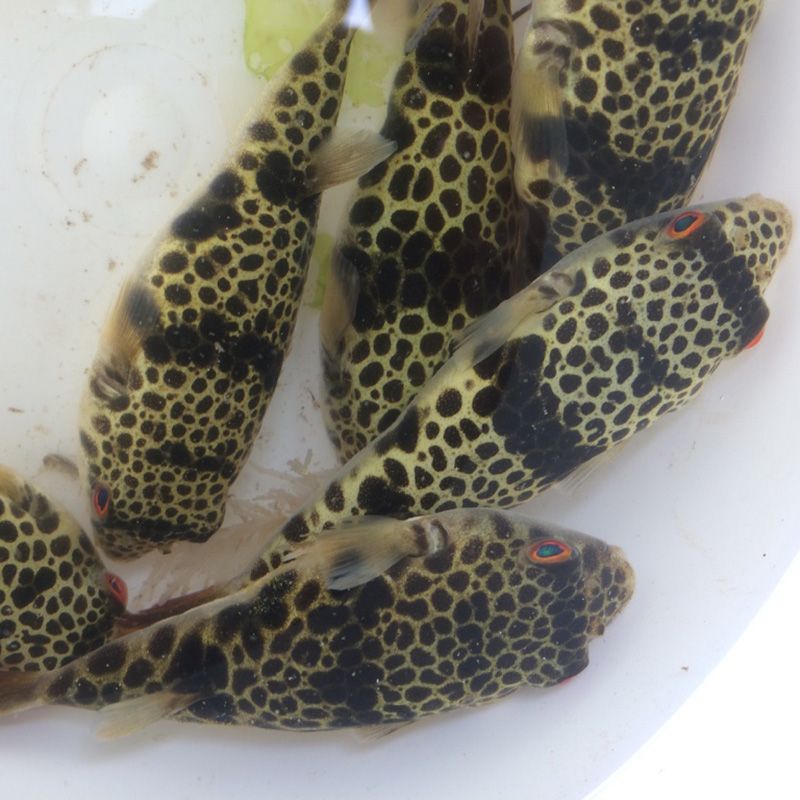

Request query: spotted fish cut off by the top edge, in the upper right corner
[{"left": 513, "top": 0, "right": 763, "bottom": 270}]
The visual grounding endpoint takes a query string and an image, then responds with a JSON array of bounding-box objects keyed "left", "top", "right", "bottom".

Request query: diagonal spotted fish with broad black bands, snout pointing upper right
[{"left": 251, "top": 195, "right": 792, "bottom": 577}]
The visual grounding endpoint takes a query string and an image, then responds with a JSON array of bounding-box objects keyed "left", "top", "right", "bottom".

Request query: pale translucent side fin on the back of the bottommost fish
[{"left": 283, "top": 517, "right": 419, "bottom": 590}]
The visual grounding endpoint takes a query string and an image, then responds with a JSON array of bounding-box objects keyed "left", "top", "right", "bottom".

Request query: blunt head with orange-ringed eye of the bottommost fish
[{"left": 519, "top": 524, "right": 635, "bottom": 656}]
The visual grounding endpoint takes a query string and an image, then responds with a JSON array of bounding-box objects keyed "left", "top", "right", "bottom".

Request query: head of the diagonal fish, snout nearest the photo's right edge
[{"left": 600, "top": 195, "right": 792, "bottom": 356}]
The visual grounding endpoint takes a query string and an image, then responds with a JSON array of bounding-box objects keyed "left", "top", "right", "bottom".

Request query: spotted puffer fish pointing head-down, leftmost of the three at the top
[{"left": 80, "top": 0, "right": 393, "bottom": 558}]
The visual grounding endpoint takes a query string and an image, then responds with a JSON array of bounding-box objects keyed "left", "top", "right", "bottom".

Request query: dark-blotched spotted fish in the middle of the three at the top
[{"left": 321, "top": 0, "right": 520, "bottom": 457}]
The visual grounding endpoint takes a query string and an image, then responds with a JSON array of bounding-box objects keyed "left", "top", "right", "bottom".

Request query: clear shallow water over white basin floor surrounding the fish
[{"left": 0, "top": 0, "right": 800, "bottom": 798}]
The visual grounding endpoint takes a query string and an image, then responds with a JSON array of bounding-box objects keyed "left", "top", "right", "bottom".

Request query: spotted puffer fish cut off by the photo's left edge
[{"left": 0, "top": 467, "right": 128, "bottom": 670}]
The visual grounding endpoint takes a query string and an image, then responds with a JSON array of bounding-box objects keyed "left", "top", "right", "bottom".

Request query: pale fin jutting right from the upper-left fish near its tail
[{"left": 305, "top": 130, "right": 397, "bottom": 195}]
